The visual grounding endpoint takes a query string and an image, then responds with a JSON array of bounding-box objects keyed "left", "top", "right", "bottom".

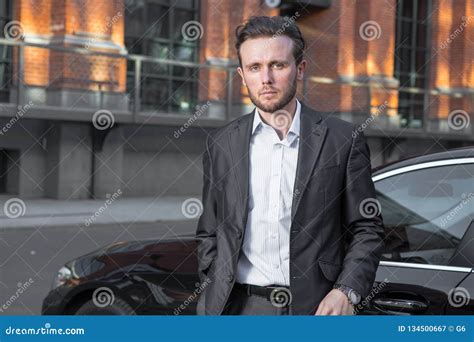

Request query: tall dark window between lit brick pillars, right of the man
[{"left": 395, "top": 0, "right": 431, "bottom": 128}]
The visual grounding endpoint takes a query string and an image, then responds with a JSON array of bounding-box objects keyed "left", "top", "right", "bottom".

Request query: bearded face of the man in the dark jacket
[{"left": 237, "top": 36, "right": 306, "bottom": 113}]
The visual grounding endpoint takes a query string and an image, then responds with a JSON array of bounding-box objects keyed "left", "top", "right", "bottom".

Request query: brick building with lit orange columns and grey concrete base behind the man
[{"left": 0, "top": 0, "right": 474, "bottom": 199}]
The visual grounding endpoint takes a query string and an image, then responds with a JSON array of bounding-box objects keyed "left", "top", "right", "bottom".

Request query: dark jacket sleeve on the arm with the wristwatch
[{"left": 336, "top": 131, "right": 384, "bottom": 298}]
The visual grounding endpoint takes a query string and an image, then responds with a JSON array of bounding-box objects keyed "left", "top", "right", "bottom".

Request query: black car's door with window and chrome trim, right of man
[{"left": 357, "top": 158, "right": 474, "bottom": 315}]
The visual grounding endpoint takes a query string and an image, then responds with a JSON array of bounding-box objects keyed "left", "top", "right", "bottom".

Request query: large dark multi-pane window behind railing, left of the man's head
[{"left": 125, "top": 0, "right": 199, "bottom": 113}]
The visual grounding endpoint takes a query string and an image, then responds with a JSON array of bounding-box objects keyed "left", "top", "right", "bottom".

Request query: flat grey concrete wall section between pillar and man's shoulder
[{"left": 94, "top": 125, "right": 206, "bottom": 197}]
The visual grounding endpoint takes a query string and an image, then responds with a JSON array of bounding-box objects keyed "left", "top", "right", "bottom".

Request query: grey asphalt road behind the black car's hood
[{"left": 0, "top": 221, "right": 197, "bottom": 315}]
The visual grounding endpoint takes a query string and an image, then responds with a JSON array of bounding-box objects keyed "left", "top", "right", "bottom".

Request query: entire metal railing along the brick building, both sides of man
[{"left": 0, "top": 39, "right": 474, "bottom": 135}]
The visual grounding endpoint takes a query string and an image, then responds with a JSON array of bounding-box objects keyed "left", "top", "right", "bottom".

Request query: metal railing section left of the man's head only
[{"left": 0, "top": 38, "right": 242, "bottom": 125}]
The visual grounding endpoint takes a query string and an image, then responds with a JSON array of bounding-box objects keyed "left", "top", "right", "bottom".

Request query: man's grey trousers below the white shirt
[{"left": 222, "top": 287, "right": 291, "bottom": 316}]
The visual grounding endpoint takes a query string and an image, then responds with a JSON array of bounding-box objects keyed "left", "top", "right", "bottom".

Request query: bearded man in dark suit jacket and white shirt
[{"left": 196, "top": 17, "right": 383, "bottom": 315}]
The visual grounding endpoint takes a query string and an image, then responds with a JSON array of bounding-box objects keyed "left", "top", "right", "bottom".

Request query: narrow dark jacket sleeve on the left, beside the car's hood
[{"left": 196, "top": 137, "right": 217, "bottom": 283}]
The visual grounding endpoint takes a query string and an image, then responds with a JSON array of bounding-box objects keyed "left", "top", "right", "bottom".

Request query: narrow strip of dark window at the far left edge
[{"left": 0, "top": 0, "right": 13, "bottom": 102}]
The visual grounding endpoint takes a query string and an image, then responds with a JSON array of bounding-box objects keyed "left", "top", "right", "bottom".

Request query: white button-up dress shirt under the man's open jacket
[{"left": 236, "top": 101, "right": 301, "bottom": 286}]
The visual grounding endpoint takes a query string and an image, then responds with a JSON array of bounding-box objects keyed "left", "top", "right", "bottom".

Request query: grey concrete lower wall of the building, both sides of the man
[{"left": 0, "top": 119, "right": 468, "bottom": 199}]
